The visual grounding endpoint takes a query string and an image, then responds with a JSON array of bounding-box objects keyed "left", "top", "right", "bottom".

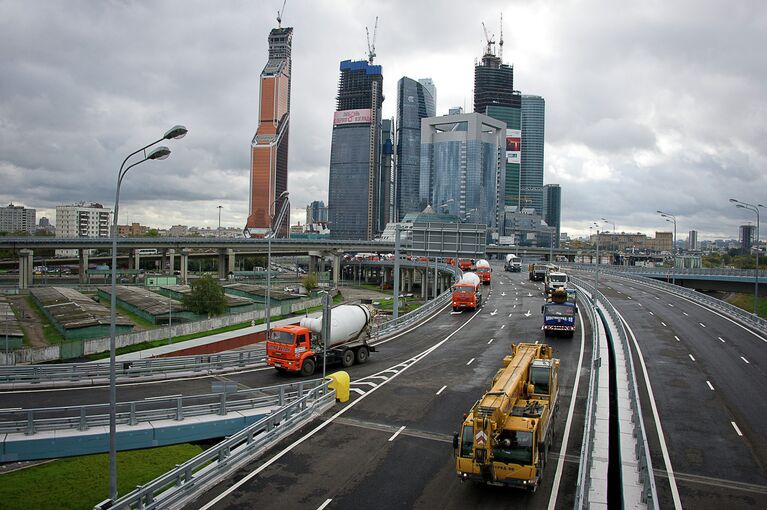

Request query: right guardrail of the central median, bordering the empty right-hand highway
[{"left": 573, "top": 278, "right": 658, "bottom": 509}]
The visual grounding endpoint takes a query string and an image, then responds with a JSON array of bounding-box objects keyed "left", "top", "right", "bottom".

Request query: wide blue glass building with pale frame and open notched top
[{"left": 420, "top": 113, "right": 506, "bottom": 232}]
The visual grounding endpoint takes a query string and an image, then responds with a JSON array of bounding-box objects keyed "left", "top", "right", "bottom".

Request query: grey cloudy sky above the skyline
[{"left": 0, "top": 0, "right": 767, "bottom": 239}]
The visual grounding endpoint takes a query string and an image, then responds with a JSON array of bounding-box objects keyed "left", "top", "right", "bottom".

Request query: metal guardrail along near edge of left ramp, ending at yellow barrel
[{"left": 0, "top": 379, "right": 322, "bottom": 435}]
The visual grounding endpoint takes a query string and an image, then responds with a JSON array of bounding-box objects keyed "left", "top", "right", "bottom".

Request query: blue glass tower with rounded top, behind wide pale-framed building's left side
[{"left": 394, "top": 77, "right": 437, "bottom": 221}]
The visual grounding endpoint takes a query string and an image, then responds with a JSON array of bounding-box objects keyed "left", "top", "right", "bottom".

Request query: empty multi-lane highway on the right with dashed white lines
[{"left": 591, "top": 276, "right": 767, "bottom": 509}]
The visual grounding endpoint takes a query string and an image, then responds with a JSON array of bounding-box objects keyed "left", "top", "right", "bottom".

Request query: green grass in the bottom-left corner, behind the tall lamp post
[{"left": 0, "top": 444, "right": 203, "bottom": 510}]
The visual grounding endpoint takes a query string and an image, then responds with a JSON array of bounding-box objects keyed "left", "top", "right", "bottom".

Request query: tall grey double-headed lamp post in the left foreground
[{"left": 109, "top": 126, "right": 187, "bottom": 501}]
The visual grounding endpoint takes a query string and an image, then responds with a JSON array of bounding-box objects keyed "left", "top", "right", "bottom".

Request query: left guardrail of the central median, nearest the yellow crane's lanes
[{"left": 571, "top": 278, "right": 601, "bottom": 510}]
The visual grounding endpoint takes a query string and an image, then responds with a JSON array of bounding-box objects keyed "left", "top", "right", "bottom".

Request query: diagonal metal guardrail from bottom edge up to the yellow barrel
[{"left": 95, "top": 380, "right": 335, "bottom": 510}]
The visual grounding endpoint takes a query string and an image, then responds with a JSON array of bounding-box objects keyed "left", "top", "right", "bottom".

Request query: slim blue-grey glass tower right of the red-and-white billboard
[{"left": 519, "top": 94, "right": 546, "bottom": 213}]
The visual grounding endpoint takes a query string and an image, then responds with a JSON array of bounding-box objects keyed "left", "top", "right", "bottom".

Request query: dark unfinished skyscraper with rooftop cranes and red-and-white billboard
[{"left": 474, "top": 47, "right": 524, "bottom": 211}]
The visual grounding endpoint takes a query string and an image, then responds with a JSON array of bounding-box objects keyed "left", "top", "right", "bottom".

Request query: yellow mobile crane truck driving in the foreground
[{"left": 453, "top": 343, "right": 559, "bottom": 491}]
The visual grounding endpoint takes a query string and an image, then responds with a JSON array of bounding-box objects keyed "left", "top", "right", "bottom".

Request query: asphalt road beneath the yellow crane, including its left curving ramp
[{"left": 0, "top": 265, "right": 590, "bottom": 508}]
